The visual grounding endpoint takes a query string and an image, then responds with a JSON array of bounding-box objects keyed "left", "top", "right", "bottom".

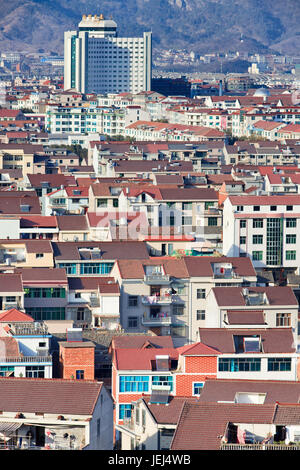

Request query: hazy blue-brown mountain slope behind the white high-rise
[{"left": 0, "top": 0, "right": 300, "bottom": 54}]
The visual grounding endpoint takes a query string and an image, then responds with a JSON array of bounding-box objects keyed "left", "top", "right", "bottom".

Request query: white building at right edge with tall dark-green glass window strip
[{"left": 223, "top": 195, "right": 300, "bottom": 270}]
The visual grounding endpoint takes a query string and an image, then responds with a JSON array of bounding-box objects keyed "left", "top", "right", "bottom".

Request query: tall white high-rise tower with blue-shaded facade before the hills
[{"left": 64, "top": 15, "right": 152, "bottom": 94}]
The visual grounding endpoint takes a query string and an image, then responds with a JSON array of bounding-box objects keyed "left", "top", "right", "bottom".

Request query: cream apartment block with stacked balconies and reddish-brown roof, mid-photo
[{"left": 111, "top": 256, "right": 256, "bottom": 347}]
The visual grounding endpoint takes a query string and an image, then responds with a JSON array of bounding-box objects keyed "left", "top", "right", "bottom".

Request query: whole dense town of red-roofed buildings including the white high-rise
[{"left": 0, "top": 15, "right": 300, "bottom": 450}]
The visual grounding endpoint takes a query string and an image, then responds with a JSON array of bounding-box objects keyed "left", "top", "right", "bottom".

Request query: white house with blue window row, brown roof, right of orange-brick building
[{"left": 200, "top": 328, "right": 298, "bottom": 382}]
